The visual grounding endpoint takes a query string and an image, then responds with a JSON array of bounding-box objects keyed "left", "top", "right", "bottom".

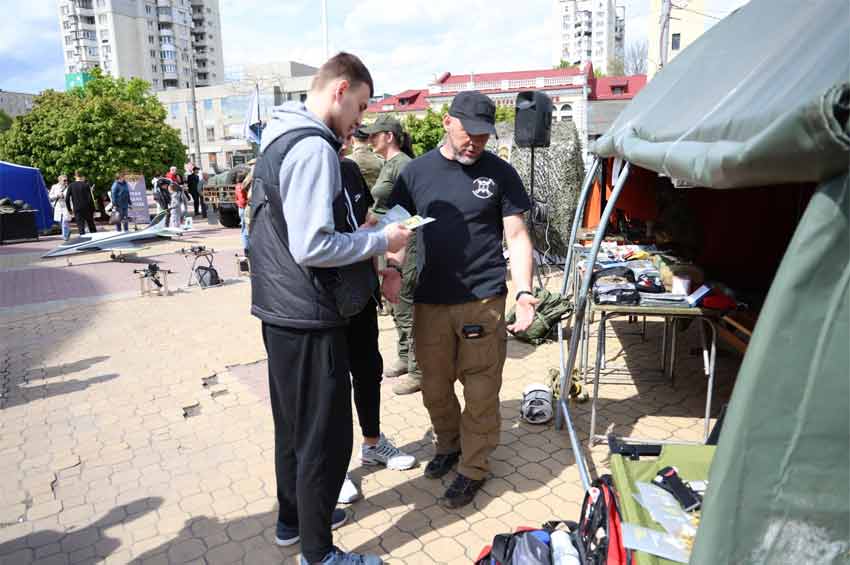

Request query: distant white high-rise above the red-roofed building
[{"left": 552, "top": 0, "right": 626, "bottom": 73}]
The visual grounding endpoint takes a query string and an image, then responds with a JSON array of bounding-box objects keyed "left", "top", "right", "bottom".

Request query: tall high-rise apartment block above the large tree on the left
[{"left": 58, "top": 0, "right": 224, "bottom": 90}]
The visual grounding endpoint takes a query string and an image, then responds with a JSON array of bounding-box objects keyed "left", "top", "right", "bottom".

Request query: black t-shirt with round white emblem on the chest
[{"left": 388, "top": 148, "right": 531, "bottom": 304}]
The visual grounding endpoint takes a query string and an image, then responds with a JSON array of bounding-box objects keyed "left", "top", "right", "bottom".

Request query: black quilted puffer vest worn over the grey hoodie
[{"left": 250, "top": 128, "right": 356, "bottom": 330}]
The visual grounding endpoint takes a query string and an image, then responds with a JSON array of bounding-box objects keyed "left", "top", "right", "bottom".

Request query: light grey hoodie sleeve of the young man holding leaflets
[{"left": 279, "top": 137, "right": 387, "bottom": 267}]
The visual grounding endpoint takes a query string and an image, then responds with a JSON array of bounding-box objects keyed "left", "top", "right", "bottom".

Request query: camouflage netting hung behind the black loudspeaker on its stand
[{"left": 487, "top": 122, "right": 584, "bottom": 257}]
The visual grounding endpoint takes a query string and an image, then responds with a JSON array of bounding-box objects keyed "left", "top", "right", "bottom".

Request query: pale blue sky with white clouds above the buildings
[{"left": 0, "top": 0, "right": 742, "bottom": 93}]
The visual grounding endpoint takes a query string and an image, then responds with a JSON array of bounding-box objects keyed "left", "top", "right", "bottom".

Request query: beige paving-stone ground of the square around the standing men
[{"left": 0, "top": 227, "right": 739, "bottom": 565}]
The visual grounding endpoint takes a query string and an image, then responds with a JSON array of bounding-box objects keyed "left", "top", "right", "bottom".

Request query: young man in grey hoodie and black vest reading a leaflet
[{"left": 251, "top": 53, "right": 410, "bottom": 565}]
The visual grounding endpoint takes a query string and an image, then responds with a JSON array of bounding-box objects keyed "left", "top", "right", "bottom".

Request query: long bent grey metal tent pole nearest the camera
[{"left": 555, "top": 162, "right": 631, "bottom": 490}]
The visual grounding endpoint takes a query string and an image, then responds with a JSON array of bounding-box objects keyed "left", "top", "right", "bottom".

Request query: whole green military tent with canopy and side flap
[{"left": 590, "top": 0, "right": 850, "bottom": 565}]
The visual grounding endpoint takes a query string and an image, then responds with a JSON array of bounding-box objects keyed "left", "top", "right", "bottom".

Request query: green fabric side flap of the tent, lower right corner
[{"left": 691, "top": 173, "right": 850, "bottom": 565}]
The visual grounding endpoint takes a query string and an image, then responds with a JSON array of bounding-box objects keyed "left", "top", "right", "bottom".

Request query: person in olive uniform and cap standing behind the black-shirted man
[{"left": 361, "top": 116, "right": 422, "bottom": 394}]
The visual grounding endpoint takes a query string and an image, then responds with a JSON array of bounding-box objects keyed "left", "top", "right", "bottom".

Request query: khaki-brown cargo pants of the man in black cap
[{"left": 413, "top": 296, "right": 507, "bottom": 480}]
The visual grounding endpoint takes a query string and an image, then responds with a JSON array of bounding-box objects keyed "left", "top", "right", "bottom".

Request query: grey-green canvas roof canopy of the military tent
[{"left": 590, "top": 0, "right": 850, "bottom": 188}]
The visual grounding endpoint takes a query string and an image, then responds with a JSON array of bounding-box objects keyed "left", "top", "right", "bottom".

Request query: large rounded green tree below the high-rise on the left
[{"left": 0, "top": 69, "right": 186, "bottom": 194}]
